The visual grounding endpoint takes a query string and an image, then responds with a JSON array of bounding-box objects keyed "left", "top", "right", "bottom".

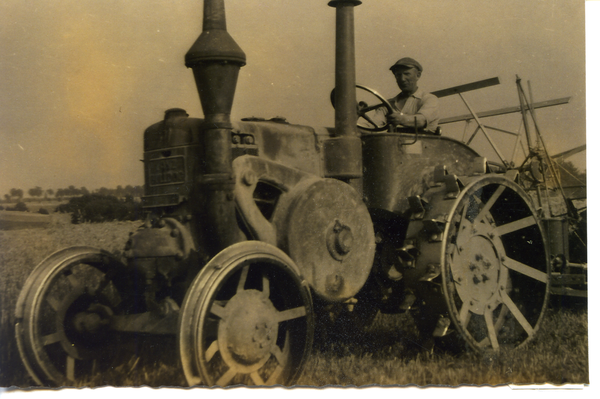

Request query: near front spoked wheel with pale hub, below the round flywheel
[{"left": 179, "top": 241, "right": 314, "bottom": 386}]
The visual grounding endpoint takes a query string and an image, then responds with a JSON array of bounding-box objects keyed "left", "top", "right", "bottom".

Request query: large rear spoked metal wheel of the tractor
[{"left": 442, "top": 177, "right": 549, "bottom": 350}]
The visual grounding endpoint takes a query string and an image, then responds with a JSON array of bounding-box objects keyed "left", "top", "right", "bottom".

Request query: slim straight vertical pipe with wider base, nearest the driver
[{"left": 324, "top": 0, "right": 362, "bottom": 179}]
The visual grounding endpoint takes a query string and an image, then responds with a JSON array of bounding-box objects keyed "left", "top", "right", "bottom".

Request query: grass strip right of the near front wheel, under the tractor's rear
[{"left": 298, "top": 310, "right": 589, "bottom": 386}]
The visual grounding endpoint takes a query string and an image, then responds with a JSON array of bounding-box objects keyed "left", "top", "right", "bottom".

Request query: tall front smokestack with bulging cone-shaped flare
[{"left": 185, "top": 0, "right": 246, "bottom": 255}]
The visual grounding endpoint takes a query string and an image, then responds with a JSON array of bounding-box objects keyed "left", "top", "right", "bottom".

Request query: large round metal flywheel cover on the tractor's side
[{"left": 274, "top": 179, "right": 375, "bottom": 302}]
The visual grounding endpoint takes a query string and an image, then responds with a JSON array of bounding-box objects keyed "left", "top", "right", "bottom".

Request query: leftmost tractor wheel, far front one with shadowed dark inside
[{"left": 15, "top": 247, "right": 138, "bottom": 386}]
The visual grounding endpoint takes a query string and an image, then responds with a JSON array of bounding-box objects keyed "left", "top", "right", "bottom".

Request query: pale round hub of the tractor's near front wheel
[{"left": 218, "top": 290, "right": 279, "bottom": 371}]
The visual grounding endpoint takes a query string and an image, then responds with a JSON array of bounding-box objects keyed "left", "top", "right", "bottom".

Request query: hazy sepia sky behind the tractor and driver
[{"left": 0, "top": 0, "right": 586, "bottom": 196}]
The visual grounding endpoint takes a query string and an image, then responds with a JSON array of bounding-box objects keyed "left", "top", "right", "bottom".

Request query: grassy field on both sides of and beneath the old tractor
[{"left": 0, "top": 214, "right": 589, "bottom": 387}]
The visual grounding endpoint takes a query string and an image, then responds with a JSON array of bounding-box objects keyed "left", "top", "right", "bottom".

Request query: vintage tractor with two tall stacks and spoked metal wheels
[{"left": 16, "top": 0, "right": 550, "bottom": 386}]
